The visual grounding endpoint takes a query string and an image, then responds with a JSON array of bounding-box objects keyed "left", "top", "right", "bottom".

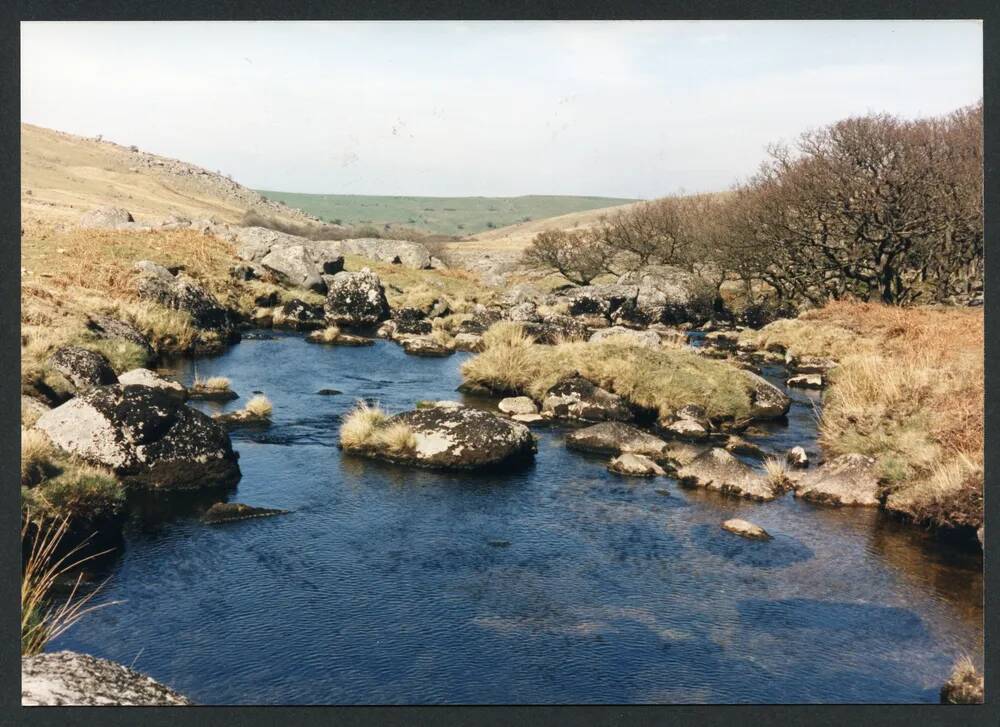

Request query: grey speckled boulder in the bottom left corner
[{"left": 21, "top": 651, "right": 191, "bottom": 707}]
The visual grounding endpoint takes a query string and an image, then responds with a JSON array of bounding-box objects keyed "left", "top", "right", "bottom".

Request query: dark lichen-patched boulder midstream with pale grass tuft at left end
[{"left": 350, "top": 406, "right": 535, "bottom": 470}]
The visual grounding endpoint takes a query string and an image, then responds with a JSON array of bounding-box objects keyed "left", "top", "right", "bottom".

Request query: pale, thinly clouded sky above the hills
[{"left": 21, "top": 20, "right": 983, "bottom": 198}]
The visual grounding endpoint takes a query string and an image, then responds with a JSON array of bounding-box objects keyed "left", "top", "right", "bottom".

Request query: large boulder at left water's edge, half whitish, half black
[{"left": 35, "top": 384, "right": 240, "bottom": 489}]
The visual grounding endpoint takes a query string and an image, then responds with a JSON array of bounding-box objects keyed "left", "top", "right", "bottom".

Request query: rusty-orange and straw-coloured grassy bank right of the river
[{"left": 741, "top": 302, "right": 984, "bottom": 528}]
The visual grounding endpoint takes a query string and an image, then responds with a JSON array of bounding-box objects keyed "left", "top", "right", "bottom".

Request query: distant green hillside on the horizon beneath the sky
[{"left": 258, "top": 189, "right": 635, "bottom": 235}]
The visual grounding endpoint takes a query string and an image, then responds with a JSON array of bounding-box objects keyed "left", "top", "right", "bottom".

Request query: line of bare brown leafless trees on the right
[{"left": 524, "top": 102, "right": 983, "bottom": 305}]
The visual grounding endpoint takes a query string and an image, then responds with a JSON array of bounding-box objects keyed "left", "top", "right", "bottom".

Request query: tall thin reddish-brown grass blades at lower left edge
[{"left": 21, "top": 518, "right": 113, "bottom": 656}]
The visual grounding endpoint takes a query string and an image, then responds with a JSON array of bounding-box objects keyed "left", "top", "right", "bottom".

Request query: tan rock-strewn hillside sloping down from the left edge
[{"left": 21, "top": 124, "right": 312, "bottom": 228}]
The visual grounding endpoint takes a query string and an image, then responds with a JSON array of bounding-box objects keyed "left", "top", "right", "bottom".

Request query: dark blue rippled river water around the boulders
[{"left": 50, "top": 336, "right": 983, "bottom": 704}]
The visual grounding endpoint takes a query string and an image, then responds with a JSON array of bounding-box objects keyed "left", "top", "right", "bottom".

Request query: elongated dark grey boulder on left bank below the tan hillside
[{"left": 135, "top": 260, "right": 239, "bottom": 342}]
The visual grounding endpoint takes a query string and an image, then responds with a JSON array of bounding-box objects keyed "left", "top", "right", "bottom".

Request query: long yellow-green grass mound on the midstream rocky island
[{"left": 462, "top": 321, "right": 750, "bottom": 418}]
